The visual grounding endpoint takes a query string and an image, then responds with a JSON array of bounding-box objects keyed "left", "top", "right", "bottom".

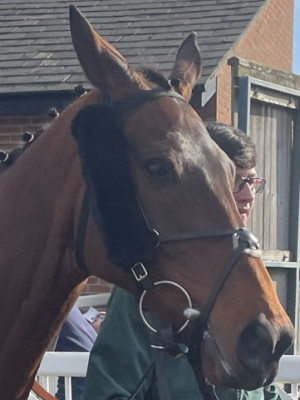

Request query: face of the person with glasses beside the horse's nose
[{"left": 233, "top": 168, "right": 257, "bottom": 225}]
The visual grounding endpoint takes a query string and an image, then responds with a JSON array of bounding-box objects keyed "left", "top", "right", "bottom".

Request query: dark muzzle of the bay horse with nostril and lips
[{"left": 196, "top": 314, "right": 294, "bottom": 390}]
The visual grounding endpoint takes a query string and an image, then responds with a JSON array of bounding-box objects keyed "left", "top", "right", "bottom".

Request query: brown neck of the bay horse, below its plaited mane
[{"left": 0, "top": 91, "right": 99, "bottom": 399}]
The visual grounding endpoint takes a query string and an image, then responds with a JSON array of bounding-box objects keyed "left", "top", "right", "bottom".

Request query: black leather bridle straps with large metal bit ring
[{"left": 75, "top": 88, "right": 259, "bottom": 394}]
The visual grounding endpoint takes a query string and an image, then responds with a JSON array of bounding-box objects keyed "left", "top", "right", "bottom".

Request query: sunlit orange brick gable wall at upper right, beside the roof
[{"left": 216, "top": 0, "right": 294, "bottom": 123}]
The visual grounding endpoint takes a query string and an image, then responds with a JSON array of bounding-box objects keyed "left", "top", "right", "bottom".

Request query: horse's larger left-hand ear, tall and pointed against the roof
[{"left": 69, "top": 5, "right": 133, "bottom": 92}]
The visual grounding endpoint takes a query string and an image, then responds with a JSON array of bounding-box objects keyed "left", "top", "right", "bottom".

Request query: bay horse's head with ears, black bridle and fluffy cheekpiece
[{"left": 70, "top": 6, "right": 293, "bottom": 389}]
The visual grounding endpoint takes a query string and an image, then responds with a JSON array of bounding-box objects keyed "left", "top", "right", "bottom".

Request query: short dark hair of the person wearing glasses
[{"left": 205, "top": 122, "right": 256, "bottom": 169}]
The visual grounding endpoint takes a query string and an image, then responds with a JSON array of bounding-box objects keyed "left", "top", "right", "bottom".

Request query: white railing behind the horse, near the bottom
[{"left": 31, "top": 352, "right": 300, "bottom": 400}]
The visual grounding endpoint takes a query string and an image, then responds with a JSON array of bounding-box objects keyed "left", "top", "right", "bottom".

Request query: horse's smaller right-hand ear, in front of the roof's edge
[{"left": 170, "top": 32, "right": 202, "bottom": 101}]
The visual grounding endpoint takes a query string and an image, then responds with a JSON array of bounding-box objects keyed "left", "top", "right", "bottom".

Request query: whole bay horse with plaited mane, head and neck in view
[{"left": 0, "top": 6, "right": 293, "bottom": 400}]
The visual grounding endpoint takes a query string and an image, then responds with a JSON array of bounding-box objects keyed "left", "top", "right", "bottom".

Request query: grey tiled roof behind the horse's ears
[{"left": 0, "top": 0, "right": 267, "bottom": 93}]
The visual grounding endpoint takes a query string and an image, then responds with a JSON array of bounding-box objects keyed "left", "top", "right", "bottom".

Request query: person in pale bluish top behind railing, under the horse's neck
[{"left": 55, "top": 305, "right": 103, "bottom": 400}]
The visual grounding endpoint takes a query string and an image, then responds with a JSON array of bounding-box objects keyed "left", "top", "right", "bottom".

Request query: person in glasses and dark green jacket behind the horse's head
[{"left": 84, "top": 122, "right": 280, "bottom": 400}]
